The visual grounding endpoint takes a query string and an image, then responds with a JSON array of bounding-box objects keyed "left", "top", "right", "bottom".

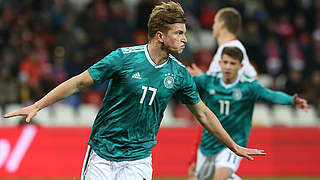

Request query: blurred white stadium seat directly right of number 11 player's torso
[{"left": 252, "top": 103, "right": 273, "bottom": 127}]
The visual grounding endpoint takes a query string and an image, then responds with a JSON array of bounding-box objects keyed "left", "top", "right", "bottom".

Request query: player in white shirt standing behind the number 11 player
[{"left": 189, "top": 7, "right": 257, "bottom": 79}]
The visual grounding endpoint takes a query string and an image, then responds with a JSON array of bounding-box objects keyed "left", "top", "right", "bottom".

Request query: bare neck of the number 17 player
[{"left": 148, "top": 41, "right": 169, "bottom": 64}]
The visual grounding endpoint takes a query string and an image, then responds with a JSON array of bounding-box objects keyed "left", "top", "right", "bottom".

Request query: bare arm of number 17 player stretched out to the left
[{"left": 4, "top": 71, "right": 94, "bottom": 122}]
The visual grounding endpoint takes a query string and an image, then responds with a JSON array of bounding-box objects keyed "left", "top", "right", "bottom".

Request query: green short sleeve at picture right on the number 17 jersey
[{"left": 177, "top": 70, "right": 200, "bottom": 104}]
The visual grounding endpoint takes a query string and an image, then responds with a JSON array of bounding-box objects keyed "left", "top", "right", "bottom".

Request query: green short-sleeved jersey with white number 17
[{"left": 88, "top": 45, "right": 200, "bottom": 161}]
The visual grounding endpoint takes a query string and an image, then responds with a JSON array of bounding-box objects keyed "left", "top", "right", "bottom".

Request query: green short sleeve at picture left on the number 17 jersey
[{"left": 88, "top": 49, "right": 124, "bottom": 83}]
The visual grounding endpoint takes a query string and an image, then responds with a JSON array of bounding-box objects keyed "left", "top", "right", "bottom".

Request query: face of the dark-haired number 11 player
[{"left": 219, "top": 54, "right": 242, "bottom": 83}]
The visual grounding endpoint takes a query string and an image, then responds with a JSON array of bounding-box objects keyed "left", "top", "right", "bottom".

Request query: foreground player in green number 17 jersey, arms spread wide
[{"left": 5, "top": 2, "right": 265, "bottom": 180}]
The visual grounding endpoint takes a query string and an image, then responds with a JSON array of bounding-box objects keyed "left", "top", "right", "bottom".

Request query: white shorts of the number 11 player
[{"left": 196, "top": 148, "right": 242, "bottom": 180}]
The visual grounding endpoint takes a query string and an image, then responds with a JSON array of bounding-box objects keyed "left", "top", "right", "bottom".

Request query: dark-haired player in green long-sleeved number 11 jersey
[{"left": 190, "top": 47, "right": 308, "bottom": 180}]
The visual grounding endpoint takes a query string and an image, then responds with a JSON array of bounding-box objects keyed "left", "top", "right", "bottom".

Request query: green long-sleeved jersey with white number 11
[{"left": 194, "top": 72, "right": 294, "bottom": 156}]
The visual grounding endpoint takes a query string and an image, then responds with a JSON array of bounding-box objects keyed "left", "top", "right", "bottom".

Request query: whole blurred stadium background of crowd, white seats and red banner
[{"left": 0, "top": 0, "right": 320, "bottom": 179}]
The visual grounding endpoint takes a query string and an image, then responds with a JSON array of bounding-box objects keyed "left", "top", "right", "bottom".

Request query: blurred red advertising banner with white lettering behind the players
[{"left": 0, "top": 126, "right": 320, "bottom": 178}]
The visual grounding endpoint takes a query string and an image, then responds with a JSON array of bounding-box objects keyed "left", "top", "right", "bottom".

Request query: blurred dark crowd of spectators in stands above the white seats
[{"left": 0, "top": 0, "right": 320, "bottom": 122}]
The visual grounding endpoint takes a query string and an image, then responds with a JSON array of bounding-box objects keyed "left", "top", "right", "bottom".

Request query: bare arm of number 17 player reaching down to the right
[{"left": 187, "top": 101, "right": 266, "bottom": 160}]
